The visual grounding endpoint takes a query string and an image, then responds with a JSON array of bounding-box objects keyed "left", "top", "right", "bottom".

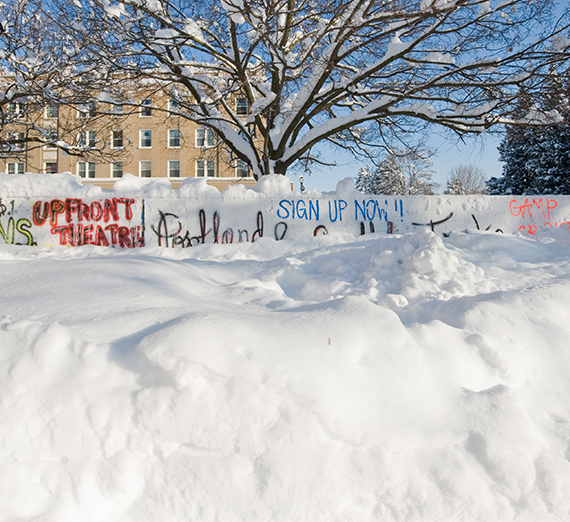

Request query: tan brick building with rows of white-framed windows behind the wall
[{"left": 0, "top": 91, "right": 255, "bottom": 190}]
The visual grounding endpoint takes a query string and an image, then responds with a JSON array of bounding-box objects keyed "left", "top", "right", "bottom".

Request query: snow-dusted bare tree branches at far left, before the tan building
[{"left": 0, "top": 0, "right": 125, "bottom": 157}]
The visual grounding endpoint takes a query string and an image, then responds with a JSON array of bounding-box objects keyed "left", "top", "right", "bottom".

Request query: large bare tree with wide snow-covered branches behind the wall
[{"left": 46, "top": 0, "right": 570, "bottom": 177}]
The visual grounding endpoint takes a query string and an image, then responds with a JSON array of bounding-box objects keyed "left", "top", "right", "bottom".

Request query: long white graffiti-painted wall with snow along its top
[{"left": 0, "top": 175, "right": 570, "bottom": 248}]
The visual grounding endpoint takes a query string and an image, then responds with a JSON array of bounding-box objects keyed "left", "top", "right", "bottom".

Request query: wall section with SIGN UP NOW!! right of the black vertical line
[{"left": 141, "top": 193, "right": 570, "bottom": 248}]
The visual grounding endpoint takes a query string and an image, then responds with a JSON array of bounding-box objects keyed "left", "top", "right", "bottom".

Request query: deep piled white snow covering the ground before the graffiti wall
[{"left": 0, "top": 223, "right": 570, "bottom": 522}]
